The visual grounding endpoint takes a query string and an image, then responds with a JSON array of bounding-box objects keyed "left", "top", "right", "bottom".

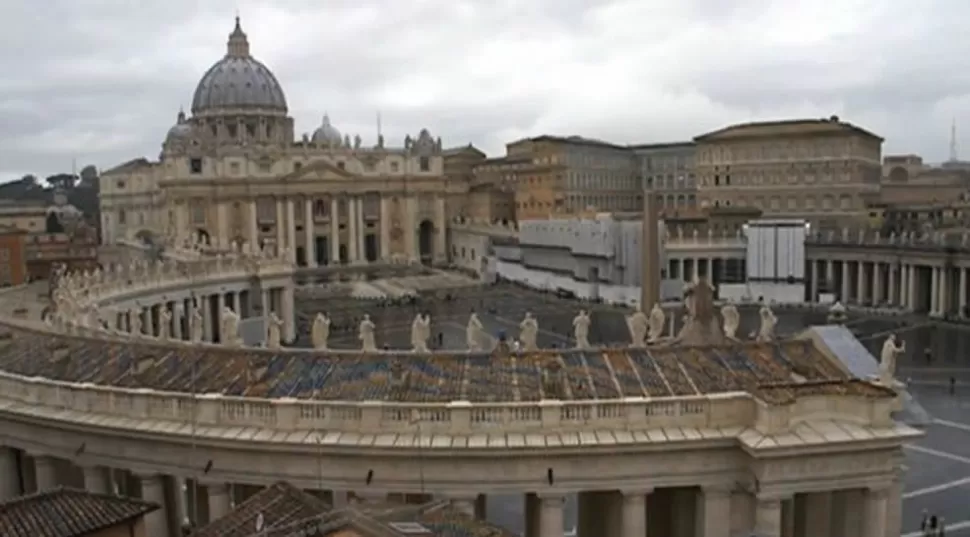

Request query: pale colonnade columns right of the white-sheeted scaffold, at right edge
[{"left": 810, "top": 259, "right": 970, "bottom": 317}]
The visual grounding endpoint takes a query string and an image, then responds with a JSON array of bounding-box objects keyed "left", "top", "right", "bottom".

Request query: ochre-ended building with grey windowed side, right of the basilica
[{"left": 506, "top": 136, "right": 643, "bottom": 220}]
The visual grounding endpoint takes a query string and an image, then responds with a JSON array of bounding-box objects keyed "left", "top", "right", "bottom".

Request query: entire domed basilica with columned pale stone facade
[{"left": 101, "top": 18, "right": 467, "bottom": 267}]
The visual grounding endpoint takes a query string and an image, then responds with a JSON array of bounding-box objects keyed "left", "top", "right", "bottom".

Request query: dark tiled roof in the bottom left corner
[{"left": 0, "top": 488, "right": 159, "bottom": 537}]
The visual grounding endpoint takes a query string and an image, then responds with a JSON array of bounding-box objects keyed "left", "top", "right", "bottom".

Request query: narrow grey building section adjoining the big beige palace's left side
[{"left": 630, "top": 142, "right": 697, "bottom": 211}]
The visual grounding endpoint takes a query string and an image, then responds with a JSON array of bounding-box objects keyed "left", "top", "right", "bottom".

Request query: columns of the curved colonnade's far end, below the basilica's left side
[{"left": 115, "top": 283, "right": 296, "bottom": 343}]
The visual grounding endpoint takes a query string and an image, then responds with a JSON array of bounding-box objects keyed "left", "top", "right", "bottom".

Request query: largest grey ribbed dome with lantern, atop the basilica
[{"left": 192, "top": 17, "right": 286, "bottom": 116}]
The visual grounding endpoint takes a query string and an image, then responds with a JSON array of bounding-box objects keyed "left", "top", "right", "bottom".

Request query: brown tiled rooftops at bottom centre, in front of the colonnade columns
[{"left": 192, "top": 482, "right": 515, "bottom": 537}]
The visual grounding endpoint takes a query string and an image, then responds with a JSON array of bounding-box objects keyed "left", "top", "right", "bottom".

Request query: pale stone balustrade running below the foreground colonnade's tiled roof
[{"left": 0, "top": 372, "right": 891, "bottom": 436}]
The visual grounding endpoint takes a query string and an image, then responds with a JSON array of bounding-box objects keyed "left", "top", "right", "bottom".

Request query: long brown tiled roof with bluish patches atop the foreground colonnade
[{"left": 0, "top": 327, "right": 893, "bottom": 404}]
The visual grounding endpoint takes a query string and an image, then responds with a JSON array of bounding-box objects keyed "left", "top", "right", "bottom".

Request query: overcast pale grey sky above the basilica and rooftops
[{"left": 0, "top": 0, "right": 970, "bottom": 180}]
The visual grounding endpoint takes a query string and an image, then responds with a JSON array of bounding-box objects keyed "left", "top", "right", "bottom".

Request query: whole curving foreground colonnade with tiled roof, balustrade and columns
[{"left": 0, "top": 240, "right": 919, "bottom": 537}]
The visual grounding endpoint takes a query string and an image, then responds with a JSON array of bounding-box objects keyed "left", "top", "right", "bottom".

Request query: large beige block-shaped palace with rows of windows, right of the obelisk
[{"left": 694, "top": 116, "right": 883, "bottom": 224}]
